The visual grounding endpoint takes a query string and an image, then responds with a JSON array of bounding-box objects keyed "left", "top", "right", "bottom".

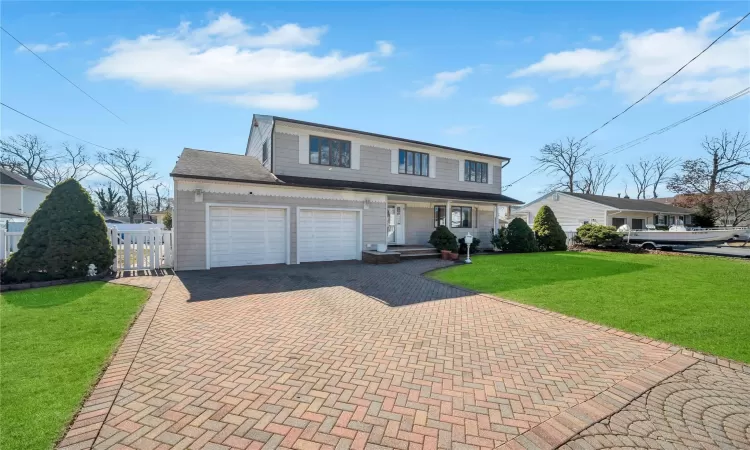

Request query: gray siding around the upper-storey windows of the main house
[{"left": 274, "top": 132, "right": 502, "bottom": 194}]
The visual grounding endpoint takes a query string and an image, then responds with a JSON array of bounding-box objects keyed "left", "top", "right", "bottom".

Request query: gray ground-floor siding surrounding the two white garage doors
[{"left": 175, "top": 190, "right": 386, "bottom": 270}]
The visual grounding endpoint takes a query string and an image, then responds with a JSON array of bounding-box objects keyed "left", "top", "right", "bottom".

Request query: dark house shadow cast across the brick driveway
[{"left": 177, "top": 259, "right": 472, "bottom": 307}]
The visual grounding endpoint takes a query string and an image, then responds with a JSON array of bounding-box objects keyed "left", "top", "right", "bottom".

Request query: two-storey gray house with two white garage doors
[{"left": 170, "top": 115, "right": 521, "bottom": 270}]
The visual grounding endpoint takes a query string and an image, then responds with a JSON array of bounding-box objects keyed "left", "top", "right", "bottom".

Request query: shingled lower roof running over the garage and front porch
[{"left": 169, "top": 148, "right": 522, "bottom": 204}]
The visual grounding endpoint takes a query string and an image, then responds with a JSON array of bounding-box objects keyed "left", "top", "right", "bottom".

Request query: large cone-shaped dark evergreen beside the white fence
[{"left": 7, "top": 179, "right": 115, "bottom": 281}]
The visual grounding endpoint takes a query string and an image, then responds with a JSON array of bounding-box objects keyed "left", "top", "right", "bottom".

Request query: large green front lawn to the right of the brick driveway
[{"left": 430, "top": 252, "right": 750, "bottom": 363}]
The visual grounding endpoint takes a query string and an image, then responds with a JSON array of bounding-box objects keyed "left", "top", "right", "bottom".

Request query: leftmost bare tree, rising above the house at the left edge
[{"left": 0, "top": 134, "right": 54, "bottom": 180}]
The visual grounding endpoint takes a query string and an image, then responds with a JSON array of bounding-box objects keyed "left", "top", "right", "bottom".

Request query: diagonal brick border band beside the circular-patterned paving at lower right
[{"left": 497, "top": 353, "right": 698, "bottom": 450}]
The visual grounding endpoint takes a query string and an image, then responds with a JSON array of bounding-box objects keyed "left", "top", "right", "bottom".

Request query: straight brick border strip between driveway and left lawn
[{"left": 55, "top": 275, "right": 172, "bottom": 450}]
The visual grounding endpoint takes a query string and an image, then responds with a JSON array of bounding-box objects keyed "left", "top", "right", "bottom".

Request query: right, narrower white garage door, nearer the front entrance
[{"left": 297, "top": 209, "right": 359, "bottom": 262}]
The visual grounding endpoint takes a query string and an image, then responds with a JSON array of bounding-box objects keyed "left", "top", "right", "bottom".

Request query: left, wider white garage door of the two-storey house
[{"left": 209, "top": 207, "right": 286, "bottom": 267}]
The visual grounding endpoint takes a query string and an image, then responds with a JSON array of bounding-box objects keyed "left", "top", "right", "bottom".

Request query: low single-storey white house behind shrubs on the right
[{"left": 512, "top": 191, "right": 691, "bottom": 231}]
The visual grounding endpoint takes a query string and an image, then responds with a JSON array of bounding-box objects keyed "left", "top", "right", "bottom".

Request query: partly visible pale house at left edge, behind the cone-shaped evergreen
[{"left": 0, "top": 168, "right": 52, "bottom": 219}]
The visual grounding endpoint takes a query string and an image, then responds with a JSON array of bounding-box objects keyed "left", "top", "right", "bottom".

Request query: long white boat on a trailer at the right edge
[{"left": 621, "top": 225, "right": 748, "bottom": 246}]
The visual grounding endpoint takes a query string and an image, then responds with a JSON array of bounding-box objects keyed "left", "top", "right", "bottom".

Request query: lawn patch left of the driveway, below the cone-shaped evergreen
[{"left": 0, "top": 282, "right": 149, "bottom": 450}]
